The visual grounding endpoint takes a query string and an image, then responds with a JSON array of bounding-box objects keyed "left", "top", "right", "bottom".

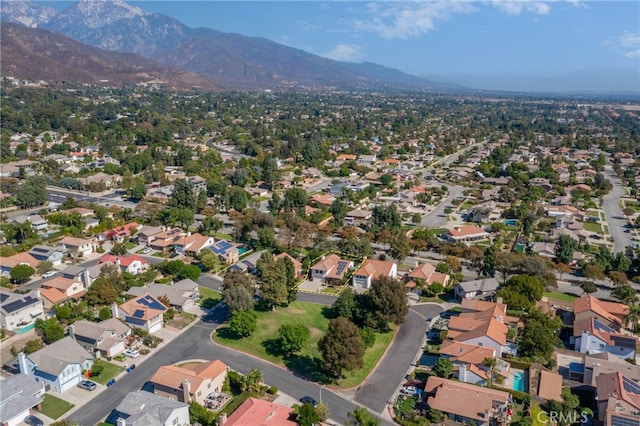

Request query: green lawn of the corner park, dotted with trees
[{"left": 212, "top": 302, "right": 394, "bottom": 388}]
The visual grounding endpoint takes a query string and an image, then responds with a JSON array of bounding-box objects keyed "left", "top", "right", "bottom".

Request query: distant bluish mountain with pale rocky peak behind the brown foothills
[{"left": 3, "top": 0, "right": 446, "bottom": 89}]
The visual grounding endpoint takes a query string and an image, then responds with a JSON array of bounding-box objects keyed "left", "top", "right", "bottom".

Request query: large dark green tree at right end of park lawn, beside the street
[{"left": 367, "top": 277, "right": 409, "bottom": 329}]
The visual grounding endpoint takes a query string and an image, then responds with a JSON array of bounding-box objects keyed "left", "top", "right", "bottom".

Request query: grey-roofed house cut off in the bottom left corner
[{"left": 0, "top": 374, "right": 45, "bottom": 426}]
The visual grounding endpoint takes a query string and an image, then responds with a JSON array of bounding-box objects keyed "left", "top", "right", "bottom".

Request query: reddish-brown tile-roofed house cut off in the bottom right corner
[{"left": 596, "top": 373, "right": 640, "bottom": 426}]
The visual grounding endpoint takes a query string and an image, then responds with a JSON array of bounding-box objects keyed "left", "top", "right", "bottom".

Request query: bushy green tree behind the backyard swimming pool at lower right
[{"left": 519, "top": 309, "right": 562, "bottom": 360}]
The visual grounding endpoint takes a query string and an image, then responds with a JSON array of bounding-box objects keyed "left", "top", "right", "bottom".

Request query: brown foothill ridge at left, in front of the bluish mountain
[{"left": 0, "top": 22, "right": 217, "bottom": 90}]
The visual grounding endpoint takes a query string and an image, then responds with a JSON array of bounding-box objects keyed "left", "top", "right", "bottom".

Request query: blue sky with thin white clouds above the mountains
[{"left": 46, "top": 0, "right": 640, "bottom": 91}]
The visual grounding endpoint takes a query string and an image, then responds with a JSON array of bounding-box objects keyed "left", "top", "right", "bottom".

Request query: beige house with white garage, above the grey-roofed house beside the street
[{"left": 68, "top": 318, "right": 131, "bottom": 357}]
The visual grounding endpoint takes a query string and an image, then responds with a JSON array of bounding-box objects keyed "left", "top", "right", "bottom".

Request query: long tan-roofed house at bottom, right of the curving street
[{"left": 424, "top": 376, "right": 511, "bottom": 426}]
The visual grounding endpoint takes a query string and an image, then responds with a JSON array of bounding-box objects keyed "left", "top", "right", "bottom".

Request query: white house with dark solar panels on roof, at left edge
[{"left": 0, "top": 290, "right": 44, "bottom": 332}]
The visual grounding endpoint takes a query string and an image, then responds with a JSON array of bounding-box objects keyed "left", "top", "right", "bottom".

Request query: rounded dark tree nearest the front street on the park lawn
[{"left": 318, "top": 317, "right": 364, "bottom": 378}]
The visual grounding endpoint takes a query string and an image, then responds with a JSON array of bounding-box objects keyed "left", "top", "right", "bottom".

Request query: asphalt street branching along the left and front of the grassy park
[{"left": 68, "top": 307, "right": 393, "bottom": 426}]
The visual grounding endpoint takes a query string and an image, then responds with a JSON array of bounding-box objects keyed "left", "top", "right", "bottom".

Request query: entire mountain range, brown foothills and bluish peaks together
[{"left": 0, "top": 0, "right": 458, "bottom": 90}]
